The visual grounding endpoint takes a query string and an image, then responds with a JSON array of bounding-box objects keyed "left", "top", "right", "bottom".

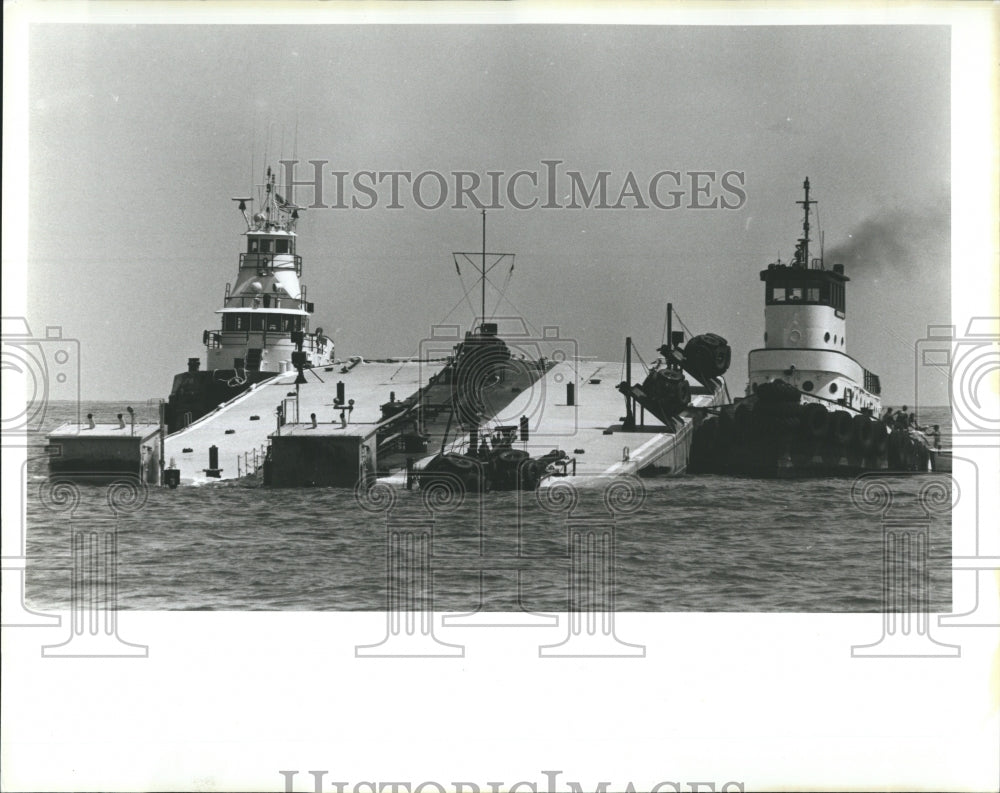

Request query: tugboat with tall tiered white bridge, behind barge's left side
[{"left": 166, "top": 163, "right": 334, "bottom": 432}]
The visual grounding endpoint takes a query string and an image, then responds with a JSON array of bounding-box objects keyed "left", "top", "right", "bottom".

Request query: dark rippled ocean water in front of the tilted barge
[{"left": 19, "top": 403, "right": 951, "bottom": 612}]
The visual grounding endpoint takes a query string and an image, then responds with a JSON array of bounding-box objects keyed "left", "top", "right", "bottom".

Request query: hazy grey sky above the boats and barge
[{"left": 21, "top": 24, "right": 951, "bottom": 404}]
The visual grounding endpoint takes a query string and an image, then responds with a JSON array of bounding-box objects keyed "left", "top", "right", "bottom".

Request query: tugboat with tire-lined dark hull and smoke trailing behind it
[{"left": 691, "top": 178, "right": 929, "bottom": 477}]
